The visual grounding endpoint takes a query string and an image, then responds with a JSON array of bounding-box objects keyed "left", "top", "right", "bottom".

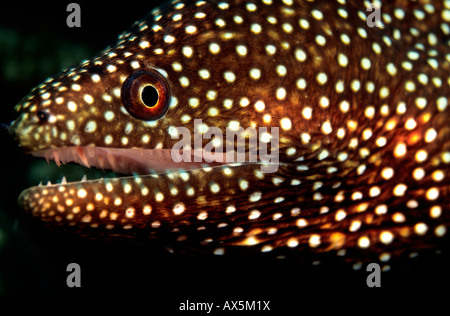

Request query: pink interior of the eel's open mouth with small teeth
[{"left": 32, "top": 146, "right": 223, "bottom": 174}]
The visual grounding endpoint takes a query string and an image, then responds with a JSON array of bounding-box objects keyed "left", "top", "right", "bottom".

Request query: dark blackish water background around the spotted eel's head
[{"left": 0, "top": 0, "right": 450, "bottom": 311}]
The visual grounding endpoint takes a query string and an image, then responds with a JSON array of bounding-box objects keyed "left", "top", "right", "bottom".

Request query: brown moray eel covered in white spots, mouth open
[{"left": 10, "top": 0, "right": 450, "bottom": 262}]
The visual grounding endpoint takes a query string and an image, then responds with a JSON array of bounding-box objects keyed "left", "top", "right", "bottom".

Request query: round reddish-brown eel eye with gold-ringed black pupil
[{"left": 121, "top": 70, "right": 170, "bottom": 121}]
